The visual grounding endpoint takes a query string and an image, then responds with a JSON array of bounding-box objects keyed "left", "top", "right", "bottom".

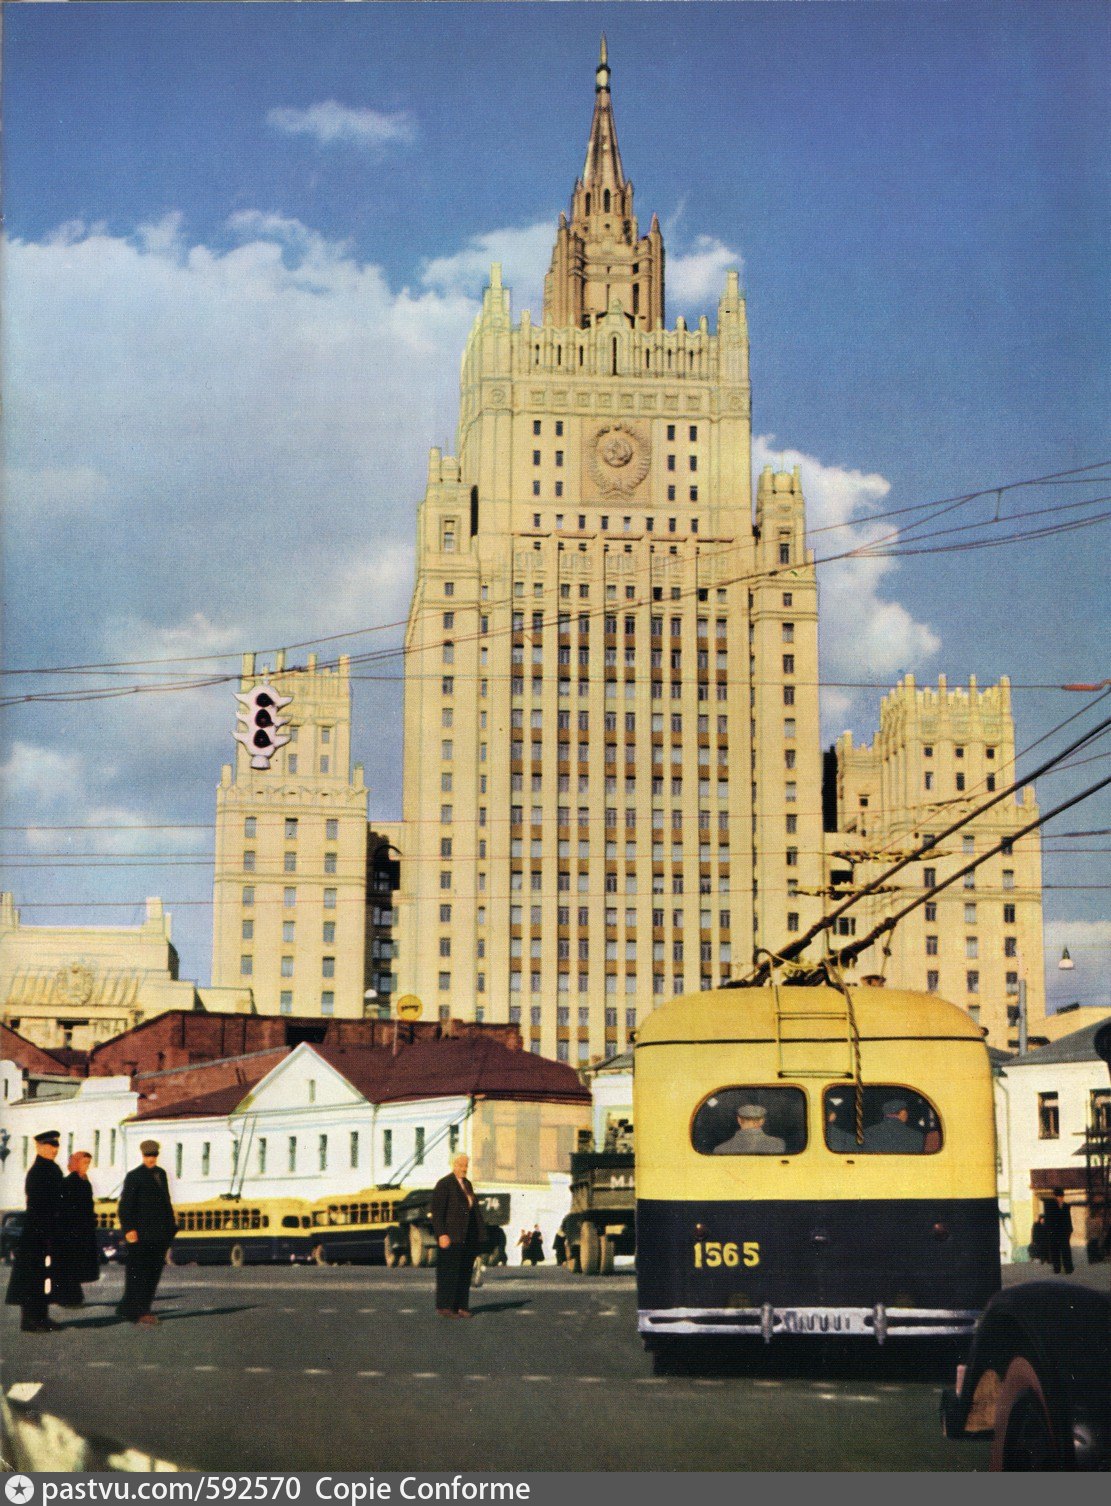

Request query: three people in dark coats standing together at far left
[{"left": 6, "top": 1130, "right": 176, "bottom": 1333}]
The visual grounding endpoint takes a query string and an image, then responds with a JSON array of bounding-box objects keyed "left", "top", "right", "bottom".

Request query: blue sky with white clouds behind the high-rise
[{"left": 3, "top": 0, "right": 1111, "bottom": 1001}]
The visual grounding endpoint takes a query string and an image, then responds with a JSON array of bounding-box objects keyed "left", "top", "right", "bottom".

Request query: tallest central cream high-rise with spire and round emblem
[{"left": 397, "top": 47, "right": 822, "bottom": 1062}]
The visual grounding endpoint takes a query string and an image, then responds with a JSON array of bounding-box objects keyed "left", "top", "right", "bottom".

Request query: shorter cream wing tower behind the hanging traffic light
[{"left": 212, "top": 652, "right": 372, "bottom": 1018}]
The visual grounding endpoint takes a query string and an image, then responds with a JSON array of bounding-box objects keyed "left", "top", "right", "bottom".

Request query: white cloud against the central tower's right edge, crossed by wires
[{"left": 753, "top": 435, "right": 941, "bottom": 738}]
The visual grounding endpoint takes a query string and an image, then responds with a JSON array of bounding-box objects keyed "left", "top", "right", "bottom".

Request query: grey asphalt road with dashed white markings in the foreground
[{"left": 0, "top": 1267, "right": 988, "bottom": 1471}]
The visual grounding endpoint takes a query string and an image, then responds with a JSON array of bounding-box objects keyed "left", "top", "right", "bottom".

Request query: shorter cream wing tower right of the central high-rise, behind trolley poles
[{"left": 826, "top": 675, "right": 1052, "bottom": 1050}]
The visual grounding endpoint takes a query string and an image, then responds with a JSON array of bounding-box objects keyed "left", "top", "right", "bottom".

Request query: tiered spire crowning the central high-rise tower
[{"left": 543, "top": 33, "right": 664, "bottom": 330}]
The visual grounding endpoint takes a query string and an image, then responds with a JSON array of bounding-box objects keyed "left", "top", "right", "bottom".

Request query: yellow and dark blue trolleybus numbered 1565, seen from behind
[{"left": 634, "top": 983, "right": 1000, "bottom": 1364}]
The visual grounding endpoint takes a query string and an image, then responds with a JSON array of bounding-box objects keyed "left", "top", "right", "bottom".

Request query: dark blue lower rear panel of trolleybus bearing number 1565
[{"left": 637, "top": 1197, "right": 1000, "bottom": 1312}]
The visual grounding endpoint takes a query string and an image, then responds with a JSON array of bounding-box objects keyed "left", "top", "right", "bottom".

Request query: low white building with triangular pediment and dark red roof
[{"left": 123, "top": 1038, "right": 590, "bottom": 1245}]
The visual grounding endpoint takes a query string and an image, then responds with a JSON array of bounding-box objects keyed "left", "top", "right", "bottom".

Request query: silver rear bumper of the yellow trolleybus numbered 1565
[{"left": 637, "top": 1303, "right": 980, "bottom": 1343}]
